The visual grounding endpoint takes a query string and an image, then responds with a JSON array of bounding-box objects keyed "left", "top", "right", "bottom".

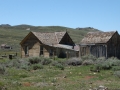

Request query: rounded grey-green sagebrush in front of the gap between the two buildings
[{"left": 66, "top": 58, "right": 82, "bottom": 66}]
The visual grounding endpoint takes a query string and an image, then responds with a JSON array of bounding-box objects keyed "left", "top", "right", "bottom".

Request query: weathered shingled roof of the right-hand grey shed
[{"left": 81, "top": 31, "right": 117, "bottom": 44}]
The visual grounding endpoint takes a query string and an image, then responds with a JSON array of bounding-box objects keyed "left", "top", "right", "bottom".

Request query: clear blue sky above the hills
[{"left": 0, "top": 0, "right": 120, "bottom": 32}]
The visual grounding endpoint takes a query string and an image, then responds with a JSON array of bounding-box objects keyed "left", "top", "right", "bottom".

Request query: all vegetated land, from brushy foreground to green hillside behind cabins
[{"left": 0, "top": 25, "right": 120, "bottom": 90}]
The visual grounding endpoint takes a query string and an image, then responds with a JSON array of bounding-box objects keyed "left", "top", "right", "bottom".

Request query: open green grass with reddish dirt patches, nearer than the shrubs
[{"left": 0, "top": 65, "right": 120, "bottom": 90}]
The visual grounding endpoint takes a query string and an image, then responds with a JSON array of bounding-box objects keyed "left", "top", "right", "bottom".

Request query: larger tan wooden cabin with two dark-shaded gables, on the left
[{"left": 20, "top": 32, "right": 79, "bottom": 58}]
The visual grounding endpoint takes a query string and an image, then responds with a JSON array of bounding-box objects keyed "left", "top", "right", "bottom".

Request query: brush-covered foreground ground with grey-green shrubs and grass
[{"left": 0, "top": 55, "right": 120, "bottom": 90}]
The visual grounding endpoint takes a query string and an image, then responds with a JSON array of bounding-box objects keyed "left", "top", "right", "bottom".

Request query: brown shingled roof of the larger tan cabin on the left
[{"left": 32, "top": 32, "right": 66, "bottom": 45}]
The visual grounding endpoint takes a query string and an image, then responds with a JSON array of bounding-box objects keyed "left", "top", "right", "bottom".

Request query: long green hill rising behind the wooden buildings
[{"left": 0, "top": 24, "right": 99, "bottom": 52}]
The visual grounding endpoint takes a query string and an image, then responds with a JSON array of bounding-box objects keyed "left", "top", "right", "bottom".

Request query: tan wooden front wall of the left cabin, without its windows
[{"left": 21, "top": 41, "right": 54, "bottom": 58}]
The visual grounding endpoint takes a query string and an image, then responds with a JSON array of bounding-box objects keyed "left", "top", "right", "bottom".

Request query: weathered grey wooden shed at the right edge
[{"left": 80, "top": 31, "right": 120, "bottom": 58}]
